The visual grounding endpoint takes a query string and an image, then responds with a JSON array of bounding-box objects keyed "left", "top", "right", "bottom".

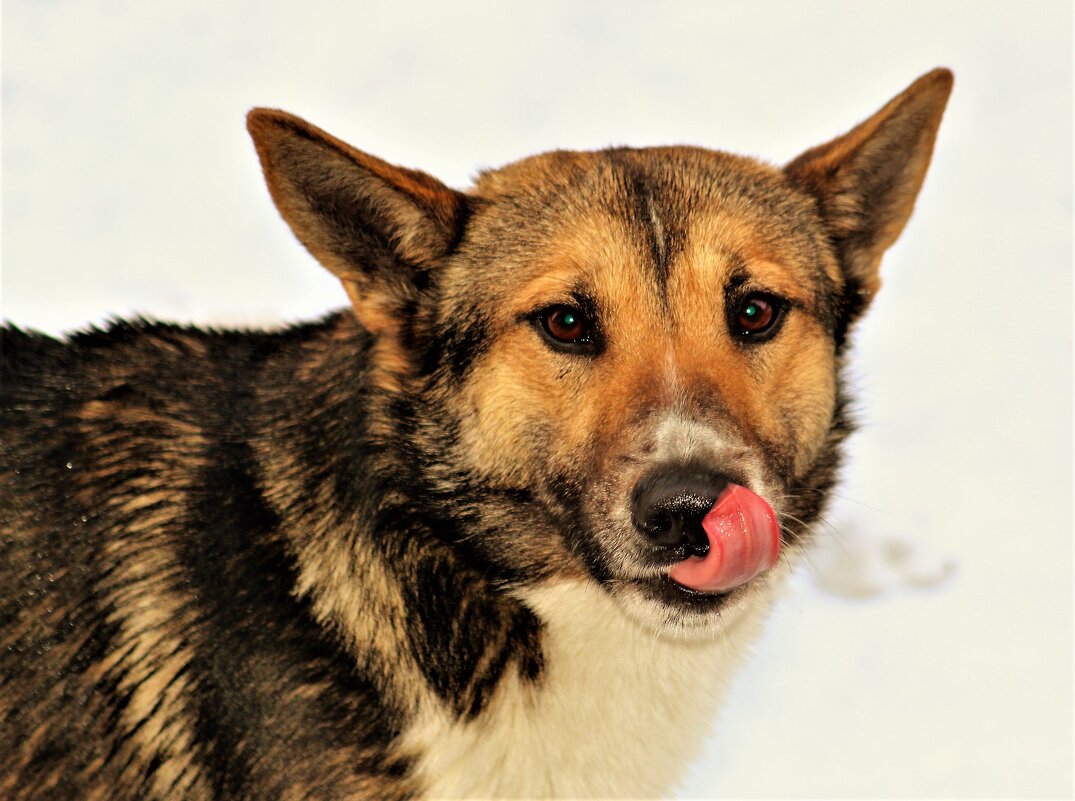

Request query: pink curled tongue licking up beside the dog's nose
[{"left": 669, "top": 484, "right": 780, "bottom": 592}]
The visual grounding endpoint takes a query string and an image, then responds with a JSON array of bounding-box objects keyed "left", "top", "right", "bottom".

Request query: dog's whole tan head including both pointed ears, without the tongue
[{"left": 249, "top": 71, "right": 951, "bottom": 634}]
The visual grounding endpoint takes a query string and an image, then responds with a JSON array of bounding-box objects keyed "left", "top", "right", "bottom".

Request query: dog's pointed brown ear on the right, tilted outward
[{"left": 784, "top": 69, "right": 952, "bottom": 309}]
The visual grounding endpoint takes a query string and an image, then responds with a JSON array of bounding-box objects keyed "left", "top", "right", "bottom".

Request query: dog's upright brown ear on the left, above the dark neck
[{"left": 246, "top": 109, "right": 467, "bottom": 333}]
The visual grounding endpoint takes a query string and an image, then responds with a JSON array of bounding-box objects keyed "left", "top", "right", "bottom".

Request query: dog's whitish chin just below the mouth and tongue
[{"left": 611, "top": 575, "right": 773, "bottom": 640}]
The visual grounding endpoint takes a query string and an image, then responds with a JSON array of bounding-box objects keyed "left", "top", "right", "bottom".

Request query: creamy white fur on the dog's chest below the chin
[{"left": 405, "top": 582, "right": 771, "bottom": 799}]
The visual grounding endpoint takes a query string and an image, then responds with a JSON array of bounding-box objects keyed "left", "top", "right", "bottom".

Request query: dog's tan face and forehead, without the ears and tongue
[{"left": 439, "top": 148, "right": 844, "bottom": 627}]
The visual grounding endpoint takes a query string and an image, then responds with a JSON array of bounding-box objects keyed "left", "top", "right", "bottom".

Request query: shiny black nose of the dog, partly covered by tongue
[{"left": 631, "top": 466, "right": 731, "bottom": 556}]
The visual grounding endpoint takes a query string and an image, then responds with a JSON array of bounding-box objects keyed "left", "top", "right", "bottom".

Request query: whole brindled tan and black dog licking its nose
[{"left": 0, "top": 69, "right": 952, "bottom": 800}]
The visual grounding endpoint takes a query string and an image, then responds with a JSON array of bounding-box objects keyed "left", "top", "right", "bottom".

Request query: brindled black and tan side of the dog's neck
[{"left": 253, "top": 313, "right": 541, "bottom": 716}]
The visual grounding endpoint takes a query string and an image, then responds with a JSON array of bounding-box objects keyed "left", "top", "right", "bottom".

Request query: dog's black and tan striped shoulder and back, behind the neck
[{"left": 0, "top": 311, "right": 414, "bottom": 799}]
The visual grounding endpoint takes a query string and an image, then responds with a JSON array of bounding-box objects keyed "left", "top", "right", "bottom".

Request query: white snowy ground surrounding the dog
[{"left": 2, "top": 0, "right": 1073, "bottom": 798}]
